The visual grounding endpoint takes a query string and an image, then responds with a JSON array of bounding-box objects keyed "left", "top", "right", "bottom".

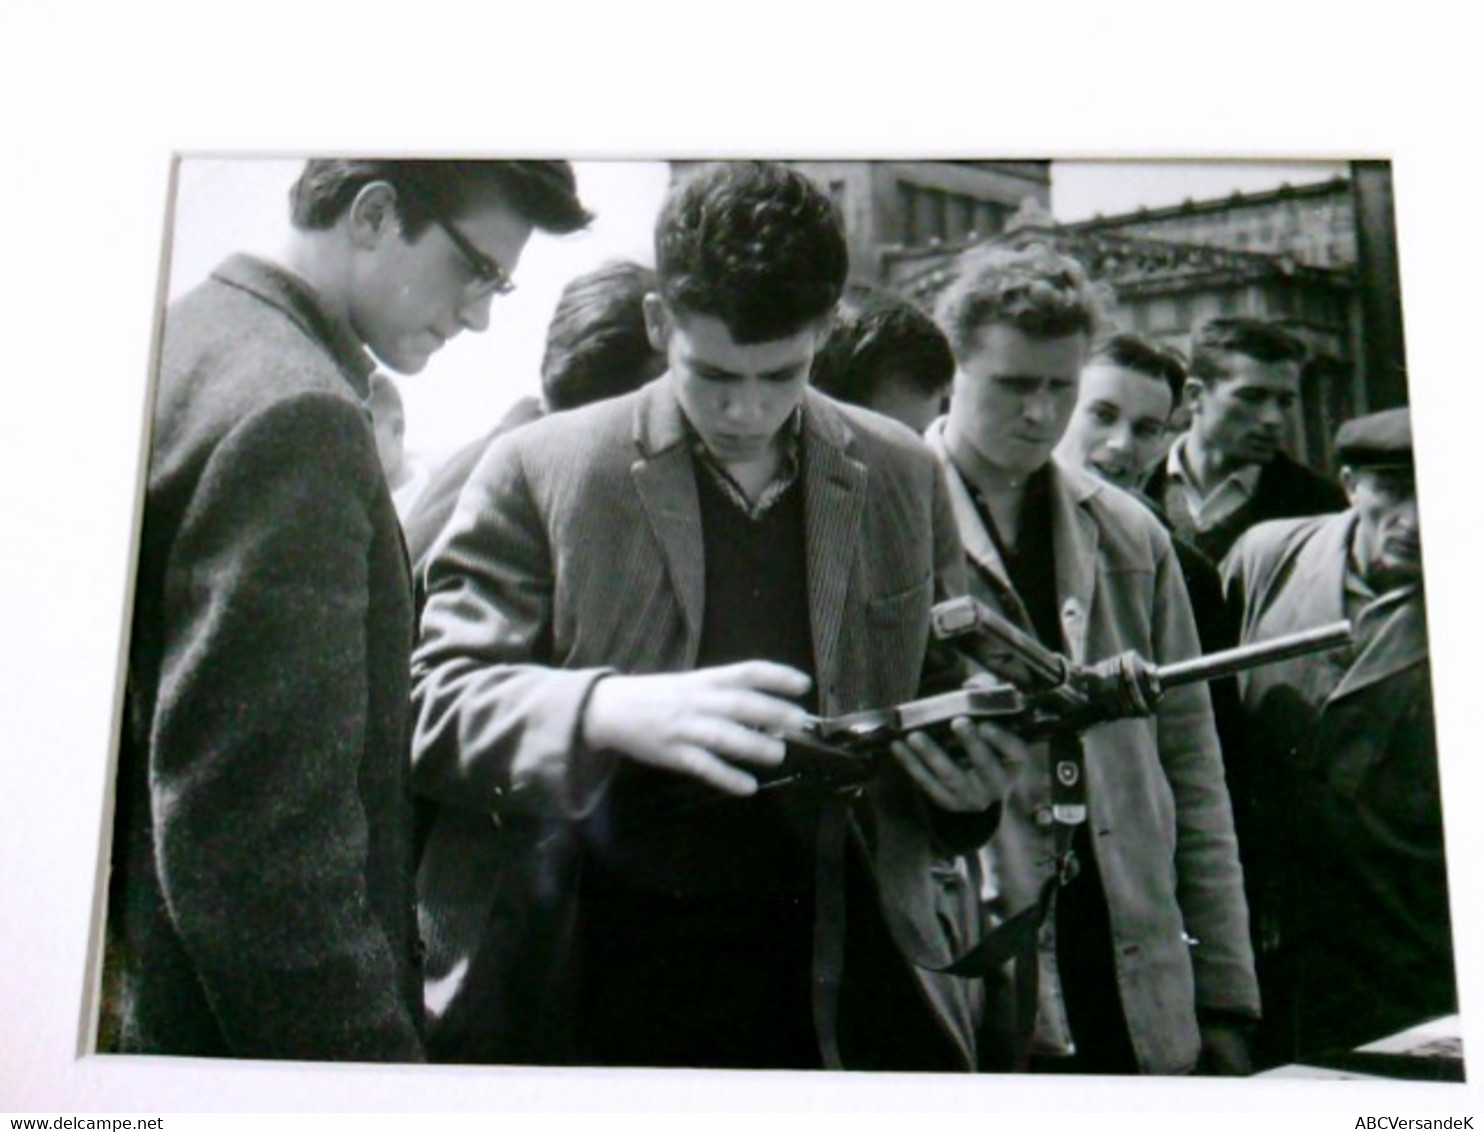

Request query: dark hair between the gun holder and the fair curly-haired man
[{"left": 809, "top": 286, "right": 954, "bottom": 405}]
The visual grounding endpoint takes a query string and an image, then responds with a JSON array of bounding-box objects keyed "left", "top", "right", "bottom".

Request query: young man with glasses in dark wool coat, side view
[{"left": 104, "top": 160, "right": 589, "bottom": 1061}]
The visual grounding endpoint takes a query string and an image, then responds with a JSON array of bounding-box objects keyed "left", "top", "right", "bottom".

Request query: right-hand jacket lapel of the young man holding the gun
[{"left": 803, "top": 395, "right": 868, "bottom": 687}]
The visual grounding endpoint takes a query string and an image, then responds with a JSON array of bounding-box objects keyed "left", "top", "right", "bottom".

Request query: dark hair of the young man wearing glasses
[{"left": 288, "top": 159, "right": 592, "bottom": 239}]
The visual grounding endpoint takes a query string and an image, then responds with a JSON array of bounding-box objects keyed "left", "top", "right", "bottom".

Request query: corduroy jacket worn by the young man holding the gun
[{"left": 414, "top": 375, "right": 978, "bottom": 1068}]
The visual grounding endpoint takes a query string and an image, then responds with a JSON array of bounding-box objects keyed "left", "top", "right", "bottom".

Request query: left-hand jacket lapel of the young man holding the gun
[{"left": 629, "top": 375, "right": 706, "bottom": 642}]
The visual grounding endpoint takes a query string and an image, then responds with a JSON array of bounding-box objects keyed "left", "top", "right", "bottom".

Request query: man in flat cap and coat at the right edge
[{"left": 1223, "top": 408, "right": 1457, "bottom": 1061}]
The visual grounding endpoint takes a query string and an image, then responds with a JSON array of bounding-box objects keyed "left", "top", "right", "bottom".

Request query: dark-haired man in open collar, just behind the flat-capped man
[{"left": 1144, "top": 319, "right": 1346, "bottom": 562}]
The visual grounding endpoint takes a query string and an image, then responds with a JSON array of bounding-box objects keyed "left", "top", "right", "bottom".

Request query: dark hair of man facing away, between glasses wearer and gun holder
[{"left": 542, "top": 260, "right": 665, "bottom": 409}]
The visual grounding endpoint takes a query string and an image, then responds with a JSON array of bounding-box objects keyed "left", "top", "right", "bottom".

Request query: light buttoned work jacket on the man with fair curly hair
[{"left": 928, "top": 421, "right": 1258, "bottom": 1074}]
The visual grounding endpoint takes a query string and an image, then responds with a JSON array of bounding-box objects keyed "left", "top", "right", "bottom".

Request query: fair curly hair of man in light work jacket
[{"left": 935, "top": 243, "right": 1106, "bottom": 358}]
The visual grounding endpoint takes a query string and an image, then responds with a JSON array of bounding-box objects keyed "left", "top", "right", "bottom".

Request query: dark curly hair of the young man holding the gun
[{"left": 654, "top": 162, "right": 849, "bottom": 344}]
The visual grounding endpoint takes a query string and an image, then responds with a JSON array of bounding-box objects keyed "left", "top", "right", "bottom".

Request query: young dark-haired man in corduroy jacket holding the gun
[{"left": 414, "top": 163, "right": 1024, "bottom": 1070}]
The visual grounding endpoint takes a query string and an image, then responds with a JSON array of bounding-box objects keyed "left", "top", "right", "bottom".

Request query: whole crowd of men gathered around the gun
[{"left": 102, "top": 160, "right": 1456, "bottom": 1074}]
